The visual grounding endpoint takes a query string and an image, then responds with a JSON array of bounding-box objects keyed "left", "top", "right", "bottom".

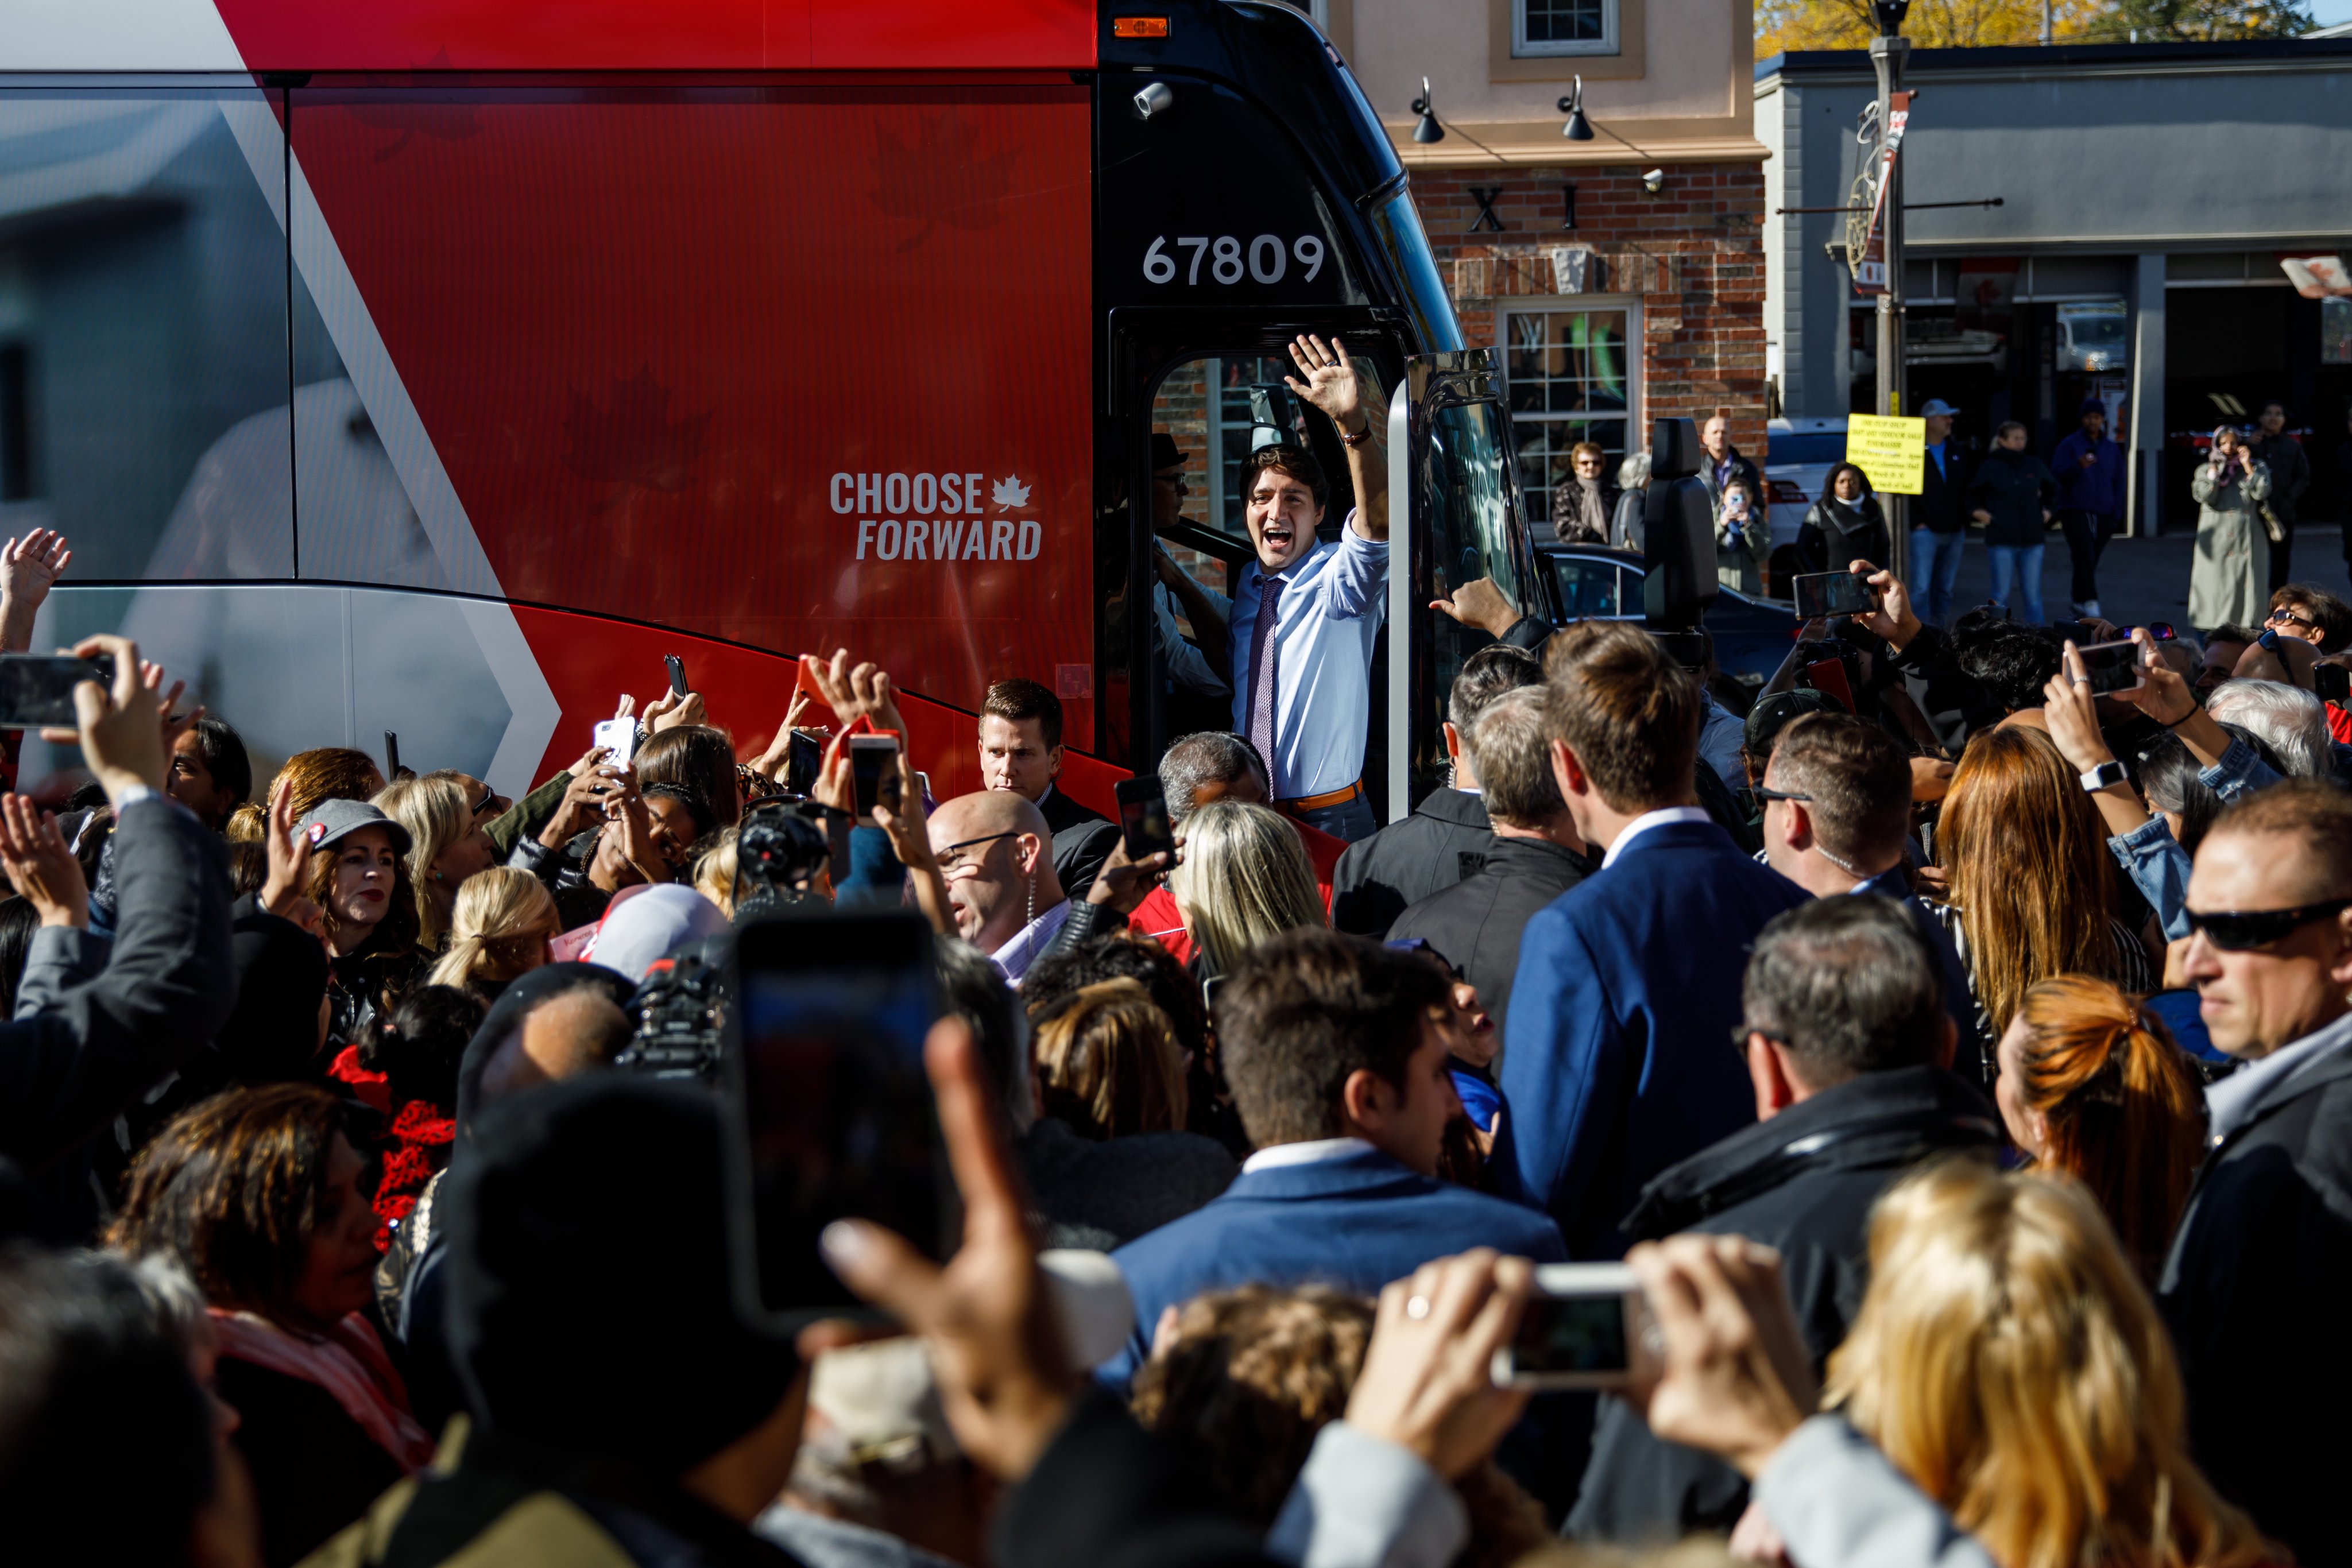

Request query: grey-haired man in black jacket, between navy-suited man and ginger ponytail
[{"left": 1569, "top": 893, "right": 1999, "bottom": 1542}]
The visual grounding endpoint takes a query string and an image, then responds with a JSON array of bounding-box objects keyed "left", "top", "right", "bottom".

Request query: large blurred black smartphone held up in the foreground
[{"left": 725, "top": 912, "right": 964, "bottom": 1333}]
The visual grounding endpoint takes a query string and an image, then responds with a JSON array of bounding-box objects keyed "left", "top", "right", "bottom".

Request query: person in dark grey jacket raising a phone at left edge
[{"left": 0, "top": 637, "right": 238, "bottom": 1244}]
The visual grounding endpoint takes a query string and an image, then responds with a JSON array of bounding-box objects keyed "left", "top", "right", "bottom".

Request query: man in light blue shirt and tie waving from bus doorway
[{"left": 1225, "top": 336, "right": 1388, "bottom": 842}]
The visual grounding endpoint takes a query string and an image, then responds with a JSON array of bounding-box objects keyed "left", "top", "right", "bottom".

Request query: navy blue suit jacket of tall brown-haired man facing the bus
[{"left": 1491, "top": 823, "right": 1811, "bottom": 1258}]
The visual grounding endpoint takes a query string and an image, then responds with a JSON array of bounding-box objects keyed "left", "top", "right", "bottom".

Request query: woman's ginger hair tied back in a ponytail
[{"left": 1992, "top": 975, "right": 2204, "bottom": 1286}]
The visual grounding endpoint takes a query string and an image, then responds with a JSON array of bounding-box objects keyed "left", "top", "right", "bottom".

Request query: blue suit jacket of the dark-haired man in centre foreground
[{"left": 1096, "top": 1149, "right": 1569, "bottom": 1389}]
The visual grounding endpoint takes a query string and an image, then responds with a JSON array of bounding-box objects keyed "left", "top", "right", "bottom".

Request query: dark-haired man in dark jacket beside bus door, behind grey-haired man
[{"left": 1331, "top": 644, "right": 1543, "bottom": 936}]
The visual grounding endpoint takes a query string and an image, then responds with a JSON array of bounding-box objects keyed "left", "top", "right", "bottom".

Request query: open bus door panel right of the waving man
[{"left": 1364, "top": 348, "right": 1560, "bottom": 823}]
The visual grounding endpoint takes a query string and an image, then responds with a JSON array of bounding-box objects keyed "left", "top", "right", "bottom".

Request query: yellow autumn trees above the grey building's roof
[{"left": 1755, "top": 0, "right": 2312, "bottom": 59}]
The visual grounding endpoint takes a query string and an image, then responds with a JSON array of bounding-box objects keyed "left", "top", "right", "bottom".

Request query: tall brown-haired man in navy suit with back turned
[{"left": 1489, "top": 621, "right": 1809, "bottom": 1258}]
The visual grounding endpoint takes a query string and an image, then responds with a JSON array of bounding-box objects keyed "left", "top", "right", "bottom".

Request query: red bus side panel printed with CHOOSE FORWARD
[{"left": 294, "top": 84, "right": 1094, "bottom": 757}]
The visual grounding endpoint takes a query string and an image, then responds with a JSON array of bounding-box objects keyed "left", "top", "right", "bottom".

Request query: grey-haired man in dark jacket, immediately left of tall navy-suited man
[{"left": 1388, "top": 687, "right": 1588, "bottom": 1037}]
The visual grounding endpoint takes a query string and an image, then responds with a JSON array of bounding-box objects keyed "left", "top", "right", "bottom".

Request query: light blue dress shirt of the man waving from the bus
[{"left": 1211, "top": 513, "right": 1388, "bottom": 799}]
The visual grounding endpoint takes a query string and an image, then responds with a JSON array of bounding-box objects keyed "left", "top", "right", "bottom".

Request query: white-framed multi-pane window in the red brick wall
[{"left": 1503, "top": 303, "right": 1639, "bottom": 524}]
